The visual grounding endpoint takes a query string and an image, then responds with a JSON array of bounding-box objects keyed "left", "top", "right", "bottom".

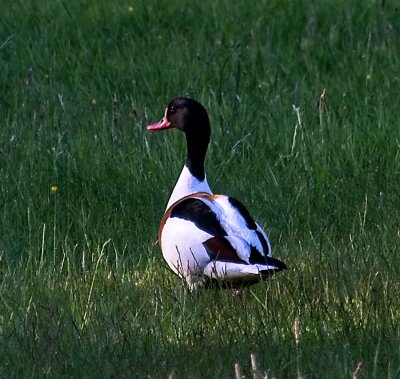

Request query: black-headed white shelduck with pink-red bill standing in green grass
[{"left": 147, "top": 97, "right": 287, "bottom": 290}]
